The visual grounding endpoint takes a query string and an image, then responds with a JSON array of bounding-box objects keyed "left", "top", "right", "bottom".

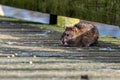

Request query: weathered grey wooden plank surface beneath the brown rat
[{"left": 0, "top": 21, "right": 120, "bottom": 80}]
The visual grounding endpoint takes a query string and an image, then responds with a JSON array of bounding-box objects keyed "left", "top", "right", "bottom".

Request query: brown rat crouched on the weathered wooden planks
[{"left": 60, "top": 21, "right": 99, "bottom": 47}]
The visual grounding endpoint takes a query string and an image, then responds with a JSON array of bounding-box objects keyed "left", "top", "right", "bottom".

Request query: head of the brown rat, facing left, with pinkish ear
[{"left": 61, "top": 27, "right": 78, "bottom": 46}]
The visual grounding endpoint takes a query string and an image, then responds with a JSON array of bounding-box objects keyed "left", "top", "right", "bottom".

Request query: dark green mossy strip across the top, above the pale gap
[{"left": 0, "top": 0, "right": 120, "bottom": 25}]
